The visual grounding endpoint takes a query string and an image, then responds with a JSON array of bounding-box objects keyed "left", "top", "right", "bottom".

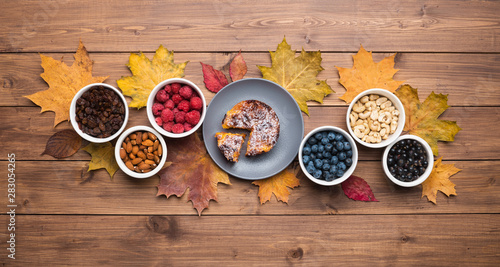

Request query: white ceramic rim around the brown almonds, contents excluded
[{"left": 115, "top": 126, "right": 167, "bottom": 179}]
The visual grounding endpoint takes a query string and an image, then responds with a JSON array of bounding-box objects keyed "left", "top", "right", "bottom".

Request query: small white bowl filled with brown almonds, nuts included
[{"left": 115, "top": 126, "right": 167, "bottom": 178}]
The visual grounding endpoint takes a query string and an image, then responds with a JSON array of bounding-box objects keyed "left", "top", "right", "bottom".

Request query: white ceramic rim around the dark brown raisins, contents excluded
[{"left": 69, "top": 83, "right": 128, "bottom": 143}]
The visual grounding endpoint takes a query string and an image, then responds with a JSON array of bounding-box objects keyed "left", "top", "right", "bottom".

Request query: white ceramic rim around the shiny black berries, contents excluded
[{"left": 382, "top": 134, "right": 434, "bottom": 187}]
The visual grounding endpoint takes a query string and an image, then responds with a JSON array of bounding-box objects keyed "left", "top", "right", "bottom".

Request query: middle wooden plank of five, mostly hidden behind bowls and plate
[{"left": 0, "top": 107, "right": 494, "bottom": 160}]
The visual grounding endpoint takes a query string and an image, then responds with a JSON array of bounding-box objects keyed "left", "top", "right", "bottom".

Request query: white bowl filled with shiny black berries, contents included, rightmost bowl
[{"left": 382, "top": 134, "right": 434, "bottom": 187}]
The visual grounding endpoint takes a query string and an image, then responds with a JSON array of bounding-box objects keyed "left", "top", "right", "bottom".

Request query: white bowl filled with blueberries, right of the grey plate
[{"left": 299, "top": 126, "right": 358, "bottom": 186}]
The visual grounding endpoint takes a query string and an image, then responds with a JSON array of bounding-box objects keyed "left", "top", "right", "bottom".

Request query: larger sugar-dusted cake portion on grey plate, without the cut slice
[{"left": 222, "top": 100, "right": 280, "bottom": 156}]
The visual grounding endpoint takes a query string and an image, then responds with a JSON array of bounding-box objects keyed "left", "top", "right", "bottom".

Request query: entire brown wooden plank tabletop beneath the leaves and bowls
[{"left": 0, "top": 0, "right": 500, "bottom": 266}]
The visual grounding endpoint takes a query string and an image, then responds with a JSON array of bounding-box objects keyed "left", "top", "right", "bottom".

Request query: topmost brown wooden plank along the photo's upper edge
[{"left": 0, "top": 0, "right": 500, "bottom": 52}]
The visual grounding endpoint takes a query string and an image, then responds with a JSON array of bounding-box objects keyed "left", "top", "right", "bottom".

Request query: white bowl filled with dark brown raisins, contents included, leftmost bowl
[{"left": 69, "top": 83, "right": 129, "bottom": 143}]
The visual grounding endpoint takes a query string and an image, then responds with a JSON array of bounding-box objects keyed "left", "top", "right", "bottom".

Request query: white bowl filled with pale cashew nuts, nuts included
[{"left": 346, "top": 88, "right": 405, "bottom": 148}]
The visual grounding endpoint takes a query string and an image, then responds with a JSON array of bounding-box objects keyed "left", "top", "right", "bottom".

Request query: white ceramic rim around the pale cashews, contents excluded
[{"left": 346, "top": 88, "right": 406, "bottom": 148}]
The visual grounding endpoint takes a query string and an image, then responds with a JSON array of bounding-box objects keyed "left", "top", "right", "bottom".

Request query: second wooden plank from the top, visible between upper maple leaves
[{"left": 0, "top": 51, "right": 500, "bottom": 106}]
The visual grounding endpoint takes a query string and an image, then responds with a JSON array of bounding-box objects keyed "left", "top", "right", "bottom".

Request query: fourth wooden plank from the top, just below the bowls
[{"left": 0, "top": 161, "right": 500, "bottom": 216}]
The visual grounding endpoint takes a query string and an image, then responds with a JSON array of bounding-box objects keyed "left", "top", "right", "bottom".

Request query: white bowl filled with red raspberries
[{"left": 147, "top": 78, "right": 206, "bottom": 138}]
